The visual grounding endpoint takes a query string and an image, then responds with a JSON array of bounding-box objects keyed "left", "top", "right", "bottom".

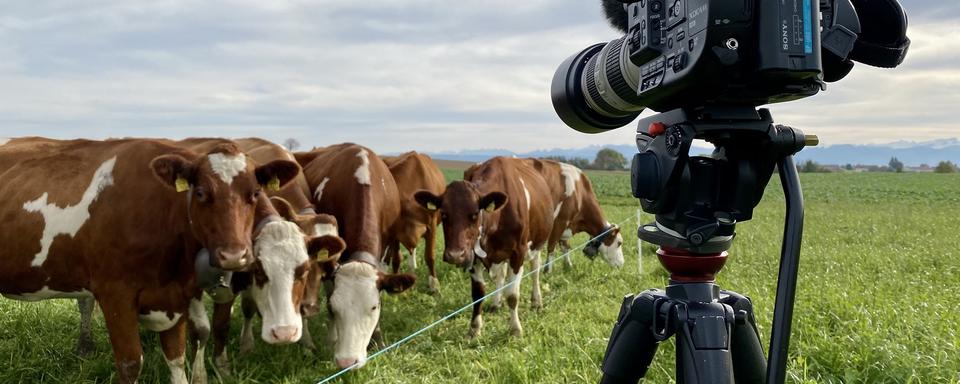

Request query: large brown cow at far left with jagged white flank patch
[{"left": 0, "top": 138, "right": 306, "bottom": 383}]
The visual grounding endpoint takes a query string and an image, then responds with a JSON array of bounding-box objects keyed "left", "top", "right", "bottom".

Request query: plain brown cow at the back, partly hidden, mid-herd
[{"left": 383, "top": 152, "right": 447, "bottom": 293}]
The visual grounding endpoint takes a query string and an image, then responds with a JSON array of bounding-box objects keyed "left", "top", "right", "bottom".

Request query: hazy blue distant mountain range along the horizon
[{"left": 429, "top": 138, "right": 960, "bottom": 166}]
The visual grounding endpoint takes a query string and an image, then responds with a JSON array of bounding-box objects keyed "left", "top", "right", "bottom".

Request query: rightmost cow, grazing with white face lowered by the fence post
[{"left": 524, "top": 158, "right": 623, "bottom": 272}]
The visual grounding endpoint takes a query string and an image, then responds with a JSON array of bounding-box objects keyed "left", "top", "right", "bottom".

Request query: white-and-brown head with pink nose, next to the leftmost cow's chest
[{"left": 242, "top": 220, "right": 346, "bottom": 344}]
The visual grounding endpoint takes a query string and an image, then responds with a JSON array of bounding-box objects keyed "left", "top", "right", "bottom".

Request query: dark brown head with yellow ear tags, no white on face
[{"left": 414, "top": 181, "right": 507, "bottom": 267}]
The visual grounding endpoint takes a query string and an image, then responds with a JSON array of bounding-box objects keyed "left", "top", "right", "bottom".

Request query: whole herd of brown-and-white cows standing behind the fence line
[{"left": 0, "top": 138, "right": 623, "bottom": 383}]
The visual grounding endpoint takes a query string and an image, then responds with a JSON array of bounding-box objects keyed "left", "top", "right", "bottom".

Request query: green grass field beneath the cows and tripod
[{"left": 0, "top": 170, "right": 960, "bottom": 384}]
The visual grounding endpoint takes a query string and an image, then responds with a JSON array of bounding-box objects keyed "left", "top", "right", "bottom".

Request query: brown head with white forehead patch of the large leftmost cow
[{"left": 150, "top": 145, "right": 300, "bottom": 270}]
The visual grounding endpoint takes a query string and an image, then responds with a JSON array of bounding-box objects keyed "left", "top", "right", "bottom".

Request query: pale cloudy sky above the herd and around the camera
[{"left": 0, "top": 0, "right": 960, "bottom": 152}]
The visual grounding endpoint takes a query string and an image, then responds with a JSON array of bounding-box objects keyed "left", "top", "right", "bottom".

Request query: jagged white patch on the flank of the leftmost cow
[{"left": 23, "top": 157, "right": 117, "bottom": 267}]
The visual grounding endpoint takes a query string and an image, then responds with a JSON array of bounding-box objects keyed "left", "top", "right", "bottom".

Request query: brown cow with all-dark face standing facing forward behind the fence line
[{"left": 415, "top": 157, "right": 553, "bottom": 338}]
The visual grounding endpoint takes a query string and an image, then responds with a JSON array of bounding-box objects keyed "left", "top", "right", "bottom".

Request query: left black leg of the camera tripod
[{"left": 600, "top": 291, "right": 659, "bottom": 384}]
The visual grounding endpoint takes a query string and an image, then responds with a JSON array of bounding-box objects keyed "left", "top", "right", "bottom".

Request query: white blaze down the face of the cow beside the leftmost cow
[{"left": 250, "top": 221, "right": 309, "bottom": 344}]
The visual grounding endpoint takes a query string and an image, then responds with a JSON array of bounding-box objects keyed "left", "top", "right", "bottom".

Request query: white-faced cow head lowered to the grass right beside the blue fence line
[{"left": 327, "top": 252, "right": 417, "bottom": 368}]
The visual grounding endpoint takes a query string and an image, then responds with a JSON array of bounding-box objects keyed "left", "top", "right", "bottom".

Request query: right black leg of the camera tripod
[{"left": 720, "top": 291, "right": 767, "bottom": 384}]
